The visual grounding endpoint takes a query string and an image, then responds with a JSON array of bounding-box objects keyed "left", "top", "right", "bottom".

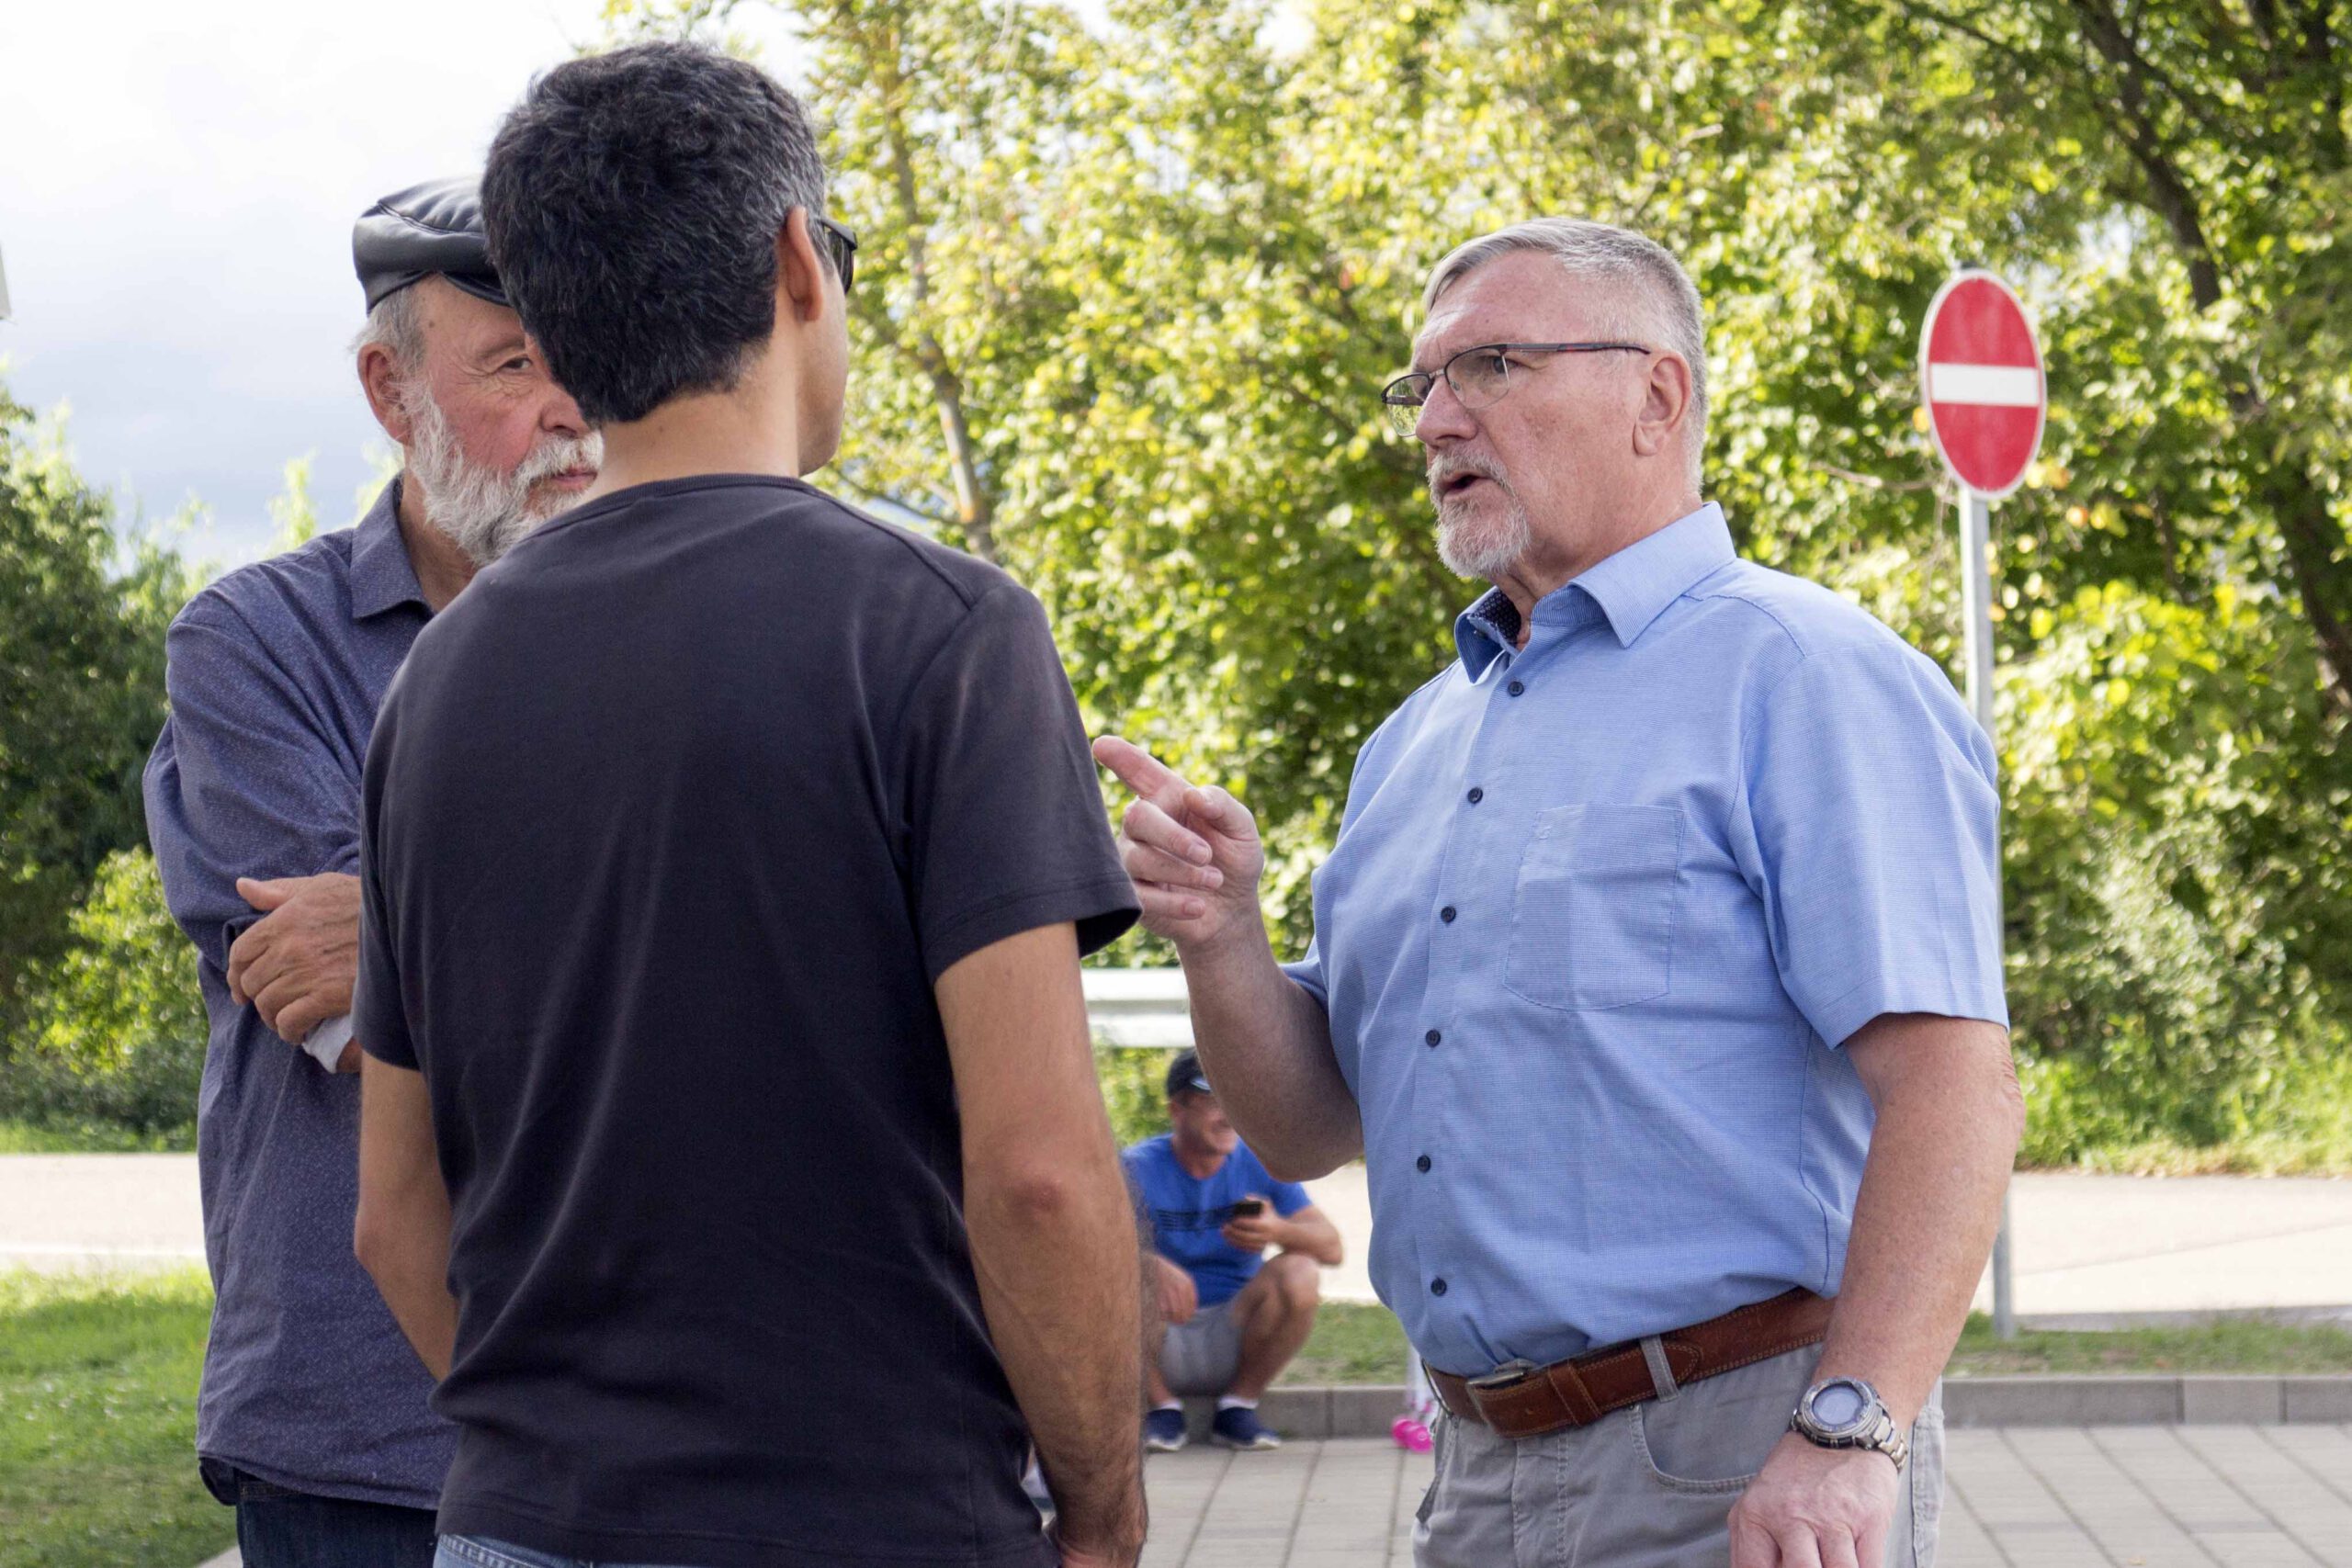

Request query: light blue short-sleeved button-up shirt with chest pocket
[{"left": 1286, "top": 505, "right": 2008, "bottom": 1375}]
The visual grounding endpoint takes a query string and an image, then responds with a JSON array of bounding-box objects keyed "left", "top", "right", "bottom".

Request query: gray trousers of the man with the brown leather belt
[{"left": 1414, "top": 1345, "right": 1943, "bottom": 1568}]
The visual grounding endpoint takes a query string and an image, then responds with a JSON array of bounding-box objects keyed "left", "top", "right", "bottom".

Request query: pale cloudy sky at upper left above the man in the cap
[{"left": 0, "top": 0, "right": 790, "bottom": 567}]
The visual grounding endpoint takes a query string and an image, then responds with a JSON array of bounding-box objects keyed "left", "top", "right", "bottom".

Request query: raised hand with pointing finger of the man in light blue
[{"left": 1093, "top": 736, "right": 1265, "bottom": 947}]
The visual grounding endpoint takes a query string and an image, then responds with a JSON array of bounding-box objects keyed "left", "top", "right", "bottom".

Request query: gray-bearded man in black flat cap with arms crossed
[{"left": 146, "top": 179, "right": 602, "bottom": 1568}]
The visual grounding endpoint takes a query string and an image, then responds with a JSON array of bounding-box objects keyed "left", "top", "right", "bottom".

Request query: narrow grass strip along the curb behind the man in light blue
[{"left": 1282, "top": 1303, "right": 2352, "bottom": 1384}]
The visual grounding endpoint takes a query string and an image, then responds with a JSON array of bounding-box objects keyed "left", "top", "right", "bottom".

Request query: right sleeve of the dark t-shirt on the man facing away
[{"left": 903, "top": 583, "right": 1141, "bottom": 983}]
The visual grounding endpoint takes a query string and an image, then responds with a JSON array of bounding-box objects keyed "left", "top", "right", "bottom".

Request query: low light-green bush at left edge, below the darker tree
[{"left": 0, "top": 849, "right": 205, "bottom": 1138}]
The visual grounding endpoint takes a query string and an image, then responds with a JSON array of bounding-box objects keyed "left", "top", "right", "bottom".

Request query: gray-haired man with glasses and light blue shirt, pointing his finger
[{"left": 1096, "top": 219, "right": 2023, "bottom": 1568}]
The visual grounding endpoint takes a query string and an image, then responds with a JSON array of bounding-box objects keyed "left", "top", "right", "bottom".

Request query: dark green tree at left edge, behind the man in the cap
[{"left": 0, "top": 390, "right": 188, "bottom": 1029}]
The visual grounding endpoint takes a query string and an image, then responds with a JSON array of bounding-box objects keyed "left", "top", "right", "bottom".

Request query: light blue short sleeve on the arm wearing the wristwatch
[{"left": 1746, "top": 637, "right": 2008, "bottom": 1046}]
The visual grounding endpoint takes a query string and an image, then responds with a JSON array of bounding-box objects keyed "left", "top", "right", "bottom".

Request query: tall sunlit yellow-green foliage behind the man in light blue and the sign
[{"left": 612, "top": 0, "right": 2352, "bottom": 1155}]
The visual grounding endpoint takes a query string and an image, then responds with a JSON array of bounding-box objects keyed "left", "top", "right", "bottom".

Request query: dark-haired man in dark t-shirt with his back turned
[{"left": 356, "top": 42, "right": 1143, "bottom": 1568}]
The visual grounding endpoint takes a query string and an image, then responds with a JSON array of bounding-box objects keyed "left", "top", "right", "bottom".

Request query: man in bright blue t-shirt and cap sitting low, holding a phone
[{"left": 1122, "top": 1051, "right": 1343, "bottom": 1453}]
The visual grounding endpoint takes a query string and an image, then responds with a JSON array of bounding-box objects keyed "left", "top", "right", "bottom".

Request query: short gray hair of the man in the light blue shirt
[{"left": 1420, "top": 219, "right": 1708, "bottom": 491}]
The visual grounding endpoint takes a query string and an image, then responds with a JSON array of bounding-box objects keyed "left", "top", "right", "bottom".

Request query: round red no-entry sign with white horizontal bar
[{"left": 1919, "top": 270, "right": 2049, "bottom": 499}]
